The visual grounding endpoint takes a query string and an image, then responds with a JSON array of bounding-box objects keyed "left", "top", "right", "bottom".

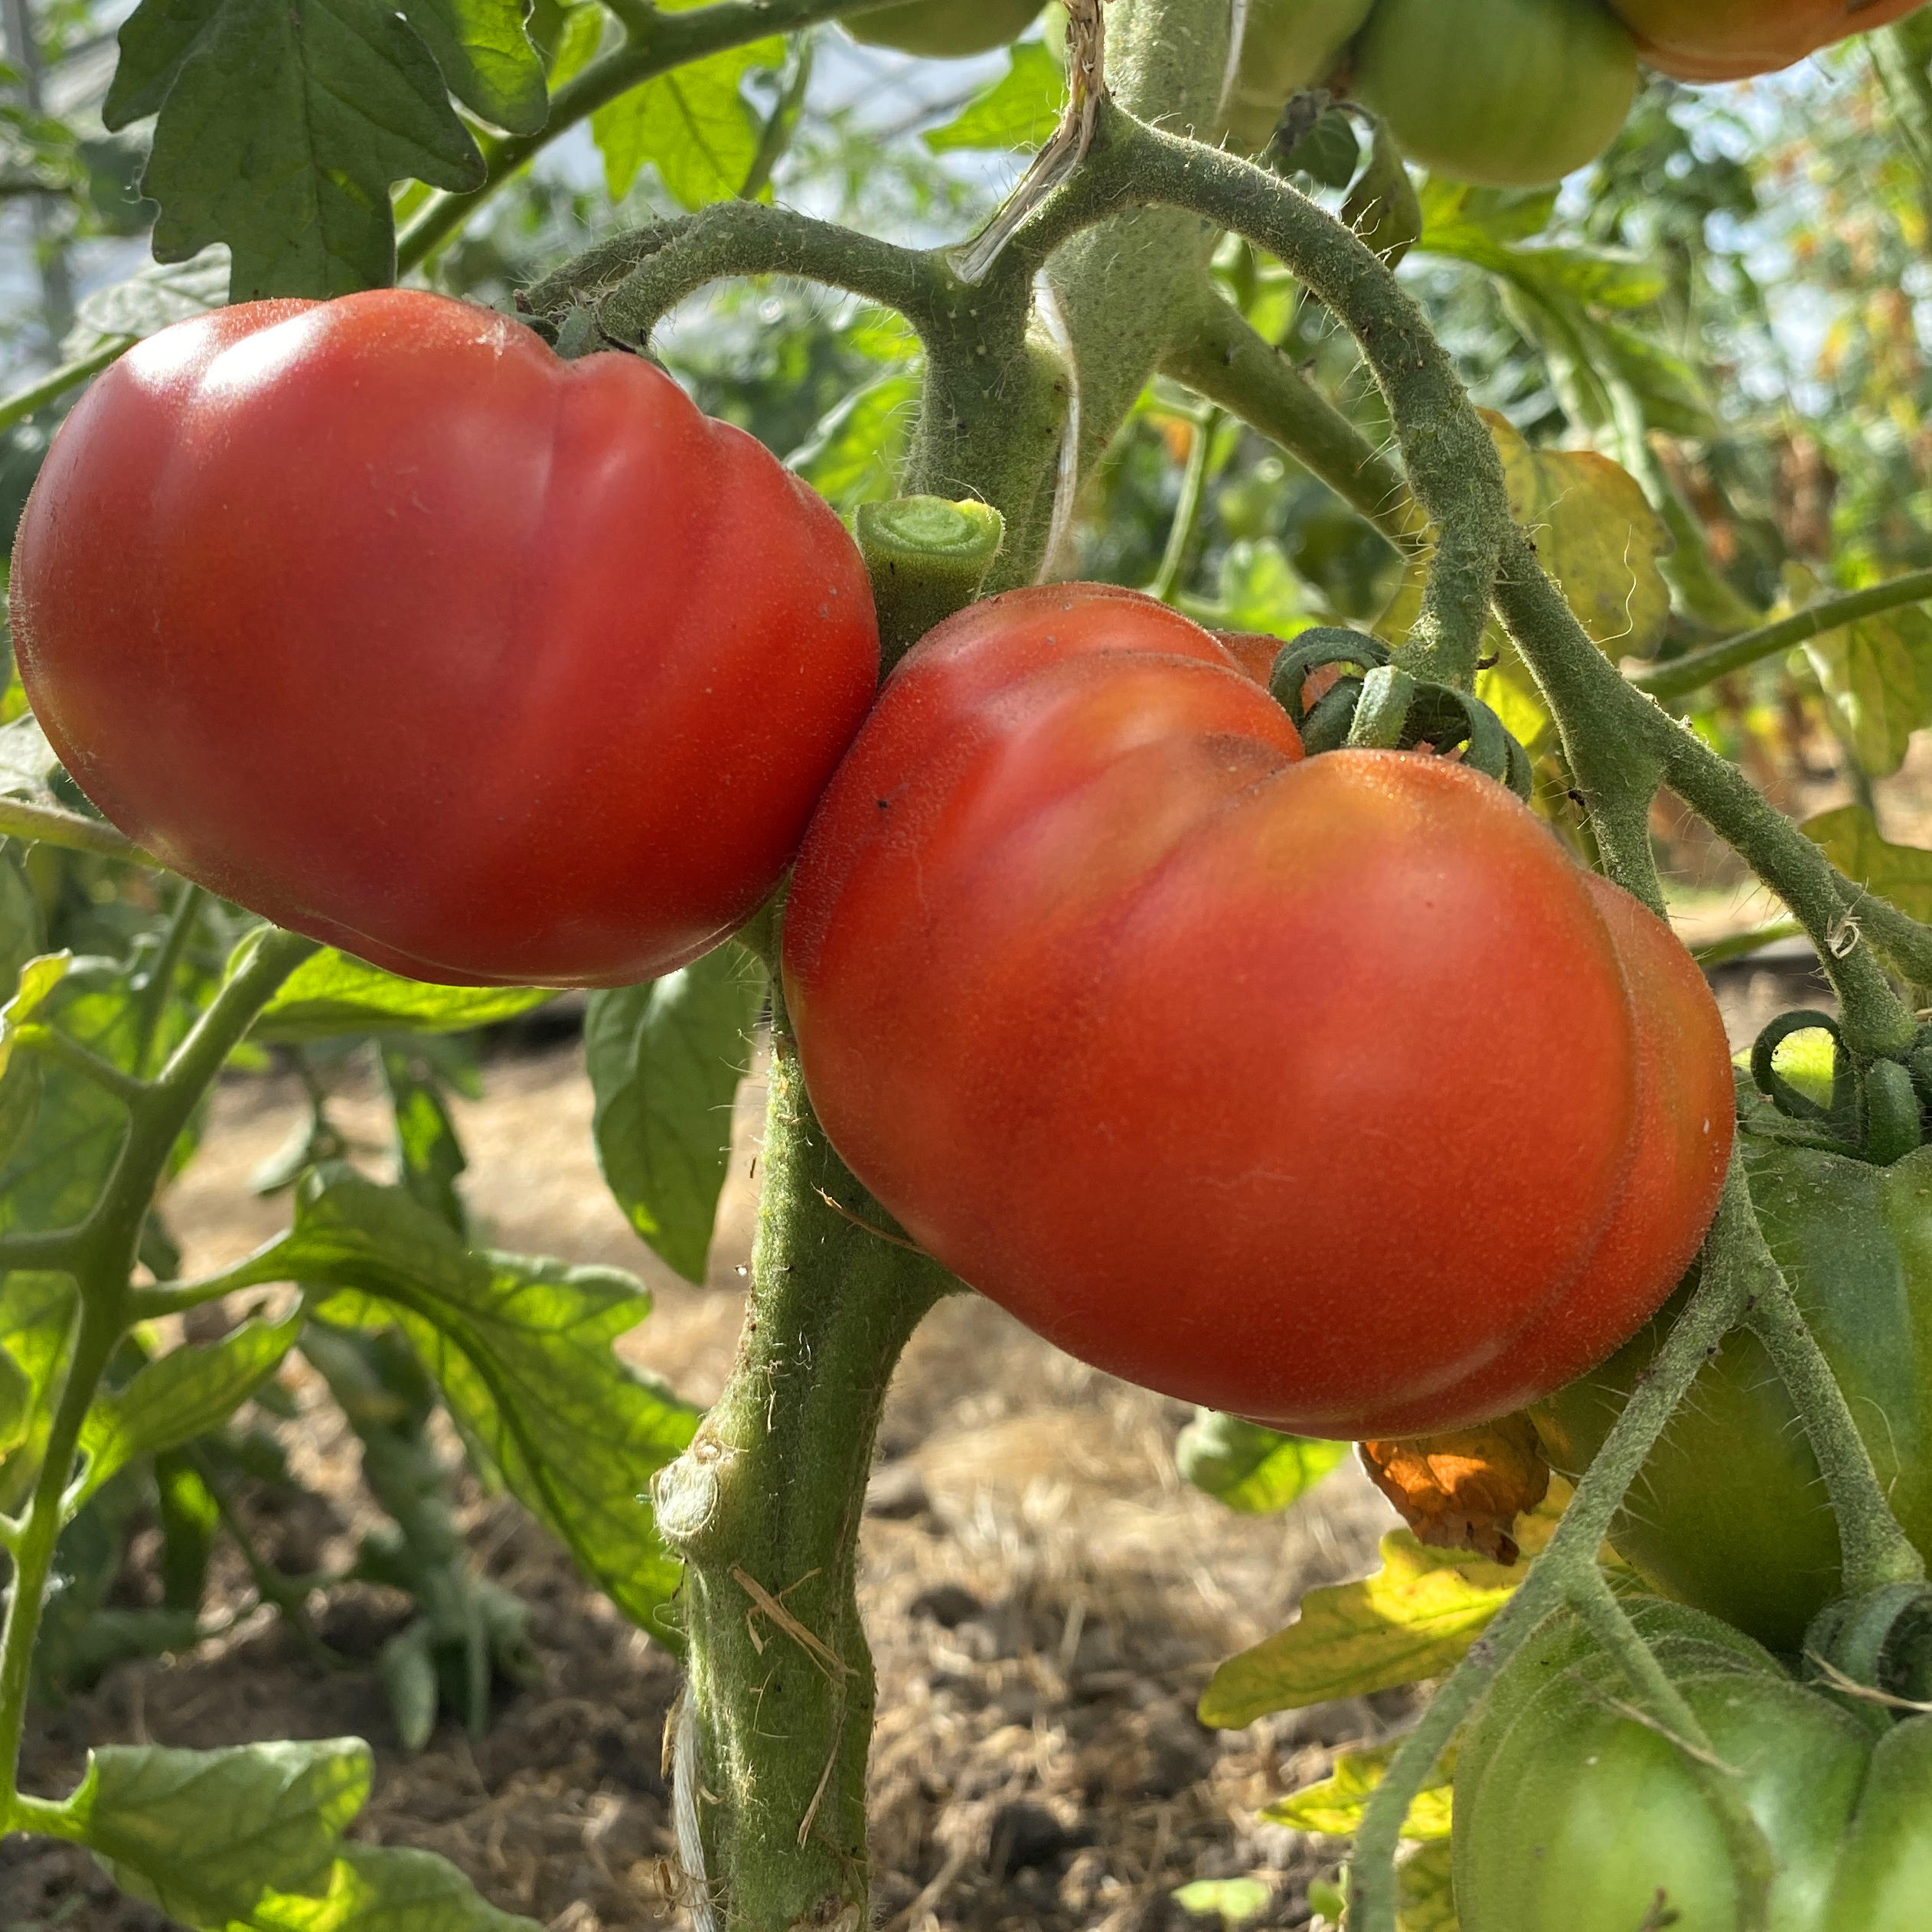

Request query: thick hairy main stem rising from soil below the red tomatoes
[{"left": 655, "top": 1022, "right": 955, "bottom": 1932}]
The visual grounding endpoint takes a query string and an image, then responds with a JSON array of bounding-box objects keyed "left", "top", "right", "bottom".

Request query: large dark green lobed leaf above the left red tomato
[{"left": 100, "top": 0, "right": 483, "bottom": 302}]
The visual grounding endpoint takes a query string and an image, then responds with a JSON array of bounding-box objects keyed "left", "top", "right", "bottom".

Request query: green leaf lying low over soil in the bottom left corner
[{"left": 62, "top": 1737, "right": 535, "bottom": 1932}]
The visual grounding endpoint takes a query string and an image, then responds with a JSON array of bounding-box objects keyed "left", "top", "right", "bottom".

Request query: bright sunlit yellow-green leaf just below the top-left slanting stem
[{"left": 591, "top": 38, "right": 785, "bottom": 209}]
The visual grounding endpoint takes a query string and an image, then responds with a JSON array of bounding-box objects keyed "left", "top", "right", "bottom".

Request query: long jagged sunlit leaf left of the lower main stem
[{"left": 224, "top": 1167, "right": 700, "bottom": 1634}]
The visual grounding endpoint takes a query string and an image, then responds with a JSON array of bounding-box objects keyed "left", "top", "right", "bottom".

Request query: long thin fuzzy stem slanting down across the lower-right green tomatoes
[{"left": 1350, "top": 1161, "right": 1764, "bottom": 1932}]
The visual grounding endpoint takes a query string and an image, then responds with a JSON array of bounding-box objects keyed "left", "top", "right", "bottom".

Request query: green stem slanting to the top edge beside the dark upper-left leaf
[{"left": 396, "top": 0, "right": 896, "bottom": 276}]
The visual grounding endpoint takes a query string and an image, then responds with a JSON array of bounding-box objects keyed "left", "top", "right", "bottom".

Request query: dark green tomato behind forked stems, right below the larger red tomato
[{"left": 1532, "top": 1113, "right": 1932, "bottom": 1661}]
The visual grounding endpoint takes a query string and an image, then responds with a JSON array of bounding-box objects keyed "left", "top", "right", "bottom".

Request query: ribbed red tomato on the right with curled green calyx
[{"left": 785, "top": 583, "right": 1731, "bottom": 1438}]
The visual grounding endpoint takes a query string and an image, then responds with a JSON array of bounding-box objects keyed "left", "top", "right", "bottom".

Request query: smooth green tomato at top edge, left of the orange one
[{"left": 1354, "top": 0, "right": 1637, "bottom": 188}]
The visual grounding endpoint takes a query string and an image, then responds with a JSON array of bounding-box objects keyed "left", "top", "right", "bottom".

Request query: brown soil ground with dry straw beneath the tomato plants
[{"left": 0, "top": 919, "right": 1839, "bottom": 1932}]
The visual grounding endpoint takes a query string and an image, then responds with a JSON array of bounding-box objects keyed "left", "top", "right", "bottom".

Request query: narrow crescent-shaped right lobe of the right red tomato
[{"left": 1376, "top": 871, "right": 1737, "bottom": 1437}]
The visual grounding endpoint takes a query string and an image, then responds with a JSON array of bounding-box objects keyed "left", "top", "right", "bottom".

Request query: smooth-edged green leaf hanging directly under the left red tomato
[{"left": 583, "top": 941, "right": 767, "bottom": 1283}]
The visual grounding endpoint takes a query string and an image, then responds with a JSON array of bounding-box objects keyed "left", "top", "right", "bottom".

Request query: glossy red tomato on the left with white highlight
[{"left": 14, "top": 290, "right": 879, "bottom": 985}]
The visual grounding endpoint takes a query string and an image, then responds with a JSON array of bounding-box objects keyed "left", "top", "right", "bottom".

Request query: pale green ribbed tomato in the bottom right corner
[{"left": 1453, "top": 1600, "right": 1932, "bottom": 1932}]
